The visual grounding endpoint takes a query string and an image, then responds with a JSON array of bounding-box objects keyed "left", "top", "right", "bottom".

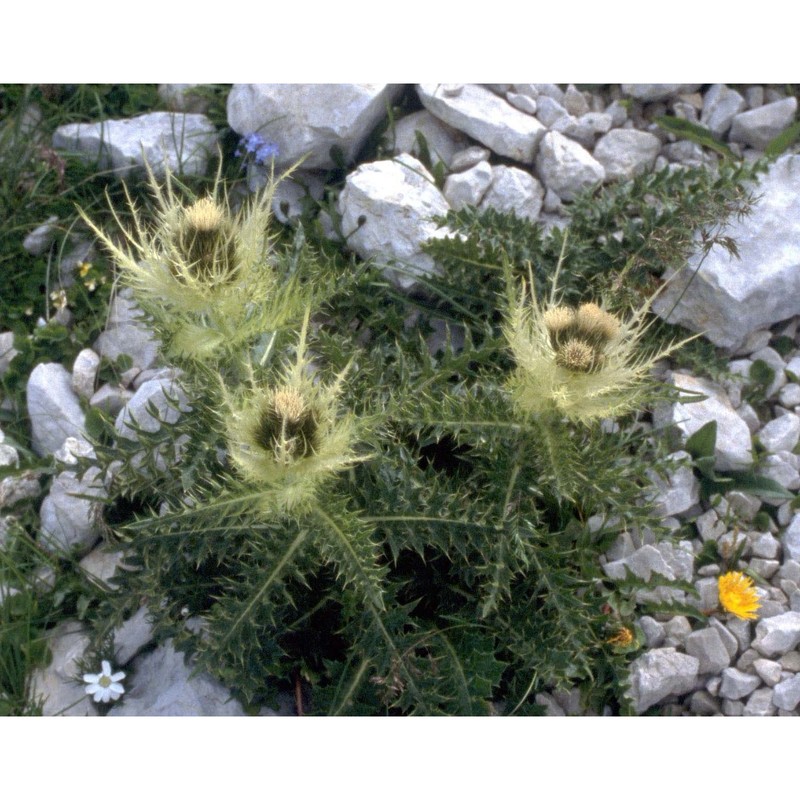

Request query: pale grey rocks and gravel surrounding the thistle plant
[{"left": 0, "top": 84, "right": 800, "bottom": 716}]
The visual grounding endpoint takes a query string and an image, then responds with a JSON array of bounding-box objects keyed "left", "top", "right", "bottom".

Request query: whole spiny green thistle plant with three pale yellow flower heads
[{"left": 0, "top": 84, "right": 754, "bottom": 715}]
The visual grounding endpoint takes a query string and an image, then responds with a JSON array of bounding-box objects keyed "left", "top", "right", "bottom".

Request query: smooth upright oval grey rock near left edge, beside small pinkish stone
[{"left": 27, "top": 364, "right": 86, "bottom": 456}]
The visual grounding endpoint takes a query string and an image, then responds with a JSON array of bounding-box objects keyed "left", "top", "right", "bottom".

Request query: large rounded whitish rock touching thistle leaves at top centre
[{"left": 339, "top": 154, "right": 449, "bottom": 289}]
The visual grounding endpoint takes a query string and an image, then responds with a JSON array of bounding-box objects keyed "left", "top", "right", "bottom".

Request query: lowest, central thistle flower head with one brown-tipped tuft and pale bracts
[{"left": 223, "top": 315, "right": 363, "bottom": 512}]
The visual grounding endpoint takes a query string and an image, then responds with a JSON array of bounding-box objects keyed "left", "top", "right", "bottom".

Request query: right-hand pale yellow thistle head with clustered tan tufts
[{"left": 505, "top": 262, "right": 682, "bottom": 424}]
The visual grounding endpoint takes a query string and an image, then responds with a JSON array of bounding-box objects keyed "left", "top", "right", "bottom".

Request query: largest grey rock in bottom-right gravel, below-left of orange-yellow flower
[{"left": 626, "top": 647, "right": 699, "bottom": 714}]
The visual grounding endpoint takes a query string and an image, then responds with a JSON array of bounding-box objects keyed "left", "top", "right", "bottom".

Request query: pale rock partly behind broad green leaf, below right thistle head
[{"left": 654, "top": 372, "right": 753, "bottom": 471}]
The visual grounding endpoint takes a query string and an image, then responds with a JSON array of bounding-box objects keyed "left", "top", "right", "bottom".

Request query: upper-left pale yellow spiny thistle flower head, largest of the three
[{"left": 82, "top": 157, "right": 305, "bottom": 360}]
